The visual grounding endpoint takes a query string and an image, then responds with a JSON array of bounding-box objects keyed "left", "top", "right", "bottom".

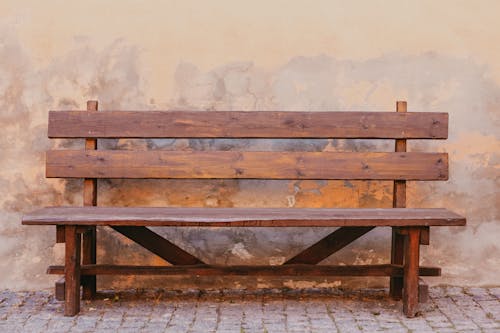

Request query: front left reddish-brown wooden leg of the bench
[{"left": 64, "top": 225, "right": 81, "bottom": 316}]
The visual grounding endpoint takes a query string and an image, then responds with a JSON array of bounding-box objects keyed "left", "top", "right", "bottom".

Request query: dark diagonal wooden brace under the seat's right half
[{"left": 283, "top": 227, "right": 375, "bottom": 265}]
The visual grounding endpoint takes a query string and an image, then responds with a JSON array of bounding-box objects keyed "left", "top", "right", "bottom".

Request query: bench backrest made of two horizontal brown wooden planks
[{"left": 46, "top": 104, "right": 448, "bottom": 180}]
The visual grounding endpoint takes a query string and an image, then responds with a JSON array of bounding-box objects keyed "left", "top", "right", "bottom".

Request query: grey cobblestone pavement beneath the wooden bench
[{"left": 0, "top": 287, "right": 500, "bottom": 333}]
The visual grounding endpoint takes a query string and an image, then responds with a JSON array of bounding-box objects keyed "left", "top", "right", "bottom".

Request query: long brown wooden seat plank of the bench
[{"left": 23, "top": 207, "right": 465, "bottom": 227}]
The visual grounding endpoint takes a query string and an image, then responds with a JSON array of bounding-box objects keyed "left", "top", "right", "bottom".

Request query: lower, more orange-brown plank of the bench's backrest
[{"left": 46, "top": 150, "right": 448, "bottom": 180}]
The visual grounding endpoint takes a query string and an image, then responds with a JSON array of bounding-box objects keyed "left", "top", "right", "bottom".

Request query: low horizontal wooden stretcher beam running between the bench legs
[{"left": 47, "top": 264, "right": 441, "bottom": 276}]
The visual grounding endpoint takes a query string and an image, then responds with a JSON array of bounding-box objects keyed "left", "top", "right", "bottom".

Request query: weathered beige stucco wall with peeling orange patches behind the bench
[{"left": 0, "top": 0, "right": 500, "bottom": 289}]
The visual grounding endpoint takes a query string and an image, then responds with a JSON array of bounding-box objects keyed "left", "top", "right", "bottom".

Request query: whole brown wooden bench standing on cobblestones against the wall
[{"left": 22, "top": 101, "right": 465, "bottom": 317}]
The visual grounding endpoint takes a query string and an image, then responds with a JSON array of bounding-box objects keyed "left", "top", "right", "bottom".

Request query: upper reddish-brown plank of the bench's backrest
[{"left": 48, "top": 111, "right": 448, "bottom": 139}]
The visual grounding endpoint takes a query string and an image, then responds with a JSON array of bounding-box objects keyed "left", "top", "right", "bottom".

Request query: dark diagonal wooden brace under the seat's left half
[{"left": 111, "top": 226, "right": 204, "bottom": 265}]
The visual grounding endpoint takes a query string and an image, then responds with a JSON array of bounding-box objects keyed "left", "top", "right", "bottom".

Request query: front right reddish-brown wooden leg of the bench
[{"left": 403, "top": 227, "right": 420, "bottom": 318}]
